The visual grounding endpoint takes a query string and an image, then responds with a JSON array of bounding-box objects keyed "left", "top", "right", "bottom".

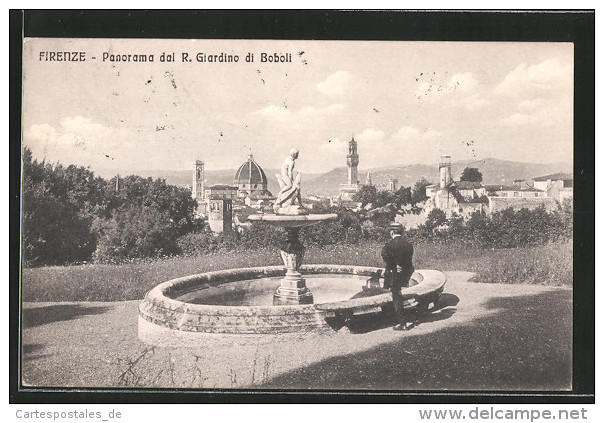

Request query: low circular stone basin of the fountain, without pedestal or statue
[{"left": 139, "top": 265, "right": 446, "bottom": 342}]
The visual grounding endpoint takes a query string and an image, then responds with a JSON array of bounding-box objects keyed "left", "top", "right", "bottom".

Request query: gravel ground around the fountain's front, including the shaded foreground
[{"left": 22, "top": 272, "right": 572, "bottom": 390}]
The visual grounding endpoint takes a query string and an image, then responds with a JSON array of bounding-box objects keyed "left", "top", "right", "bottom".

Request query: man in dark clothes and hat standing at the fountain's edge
[{"left": 382, "top": 223, "right": 415, "bottom": 330}]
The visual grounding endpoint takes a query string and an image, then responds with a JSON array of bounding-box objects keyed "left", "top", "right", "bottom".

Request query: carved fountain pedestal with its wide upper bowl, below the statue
[{"left": 248, "top": 214, "right": 338, "bottom": 305}]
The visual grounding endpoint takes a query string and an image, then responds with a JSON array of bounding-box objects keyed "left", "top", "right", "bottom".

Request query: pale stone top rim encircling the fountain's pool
[{"left": 143, "top": 264, "right": 446, "bottom": 314}]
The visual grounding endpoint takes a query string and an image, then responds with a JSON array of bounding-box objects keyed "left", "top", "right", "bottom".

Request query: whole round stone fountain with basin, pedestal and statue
[{"left": 139, "top": 149, "right": 446, "bottom": 345}]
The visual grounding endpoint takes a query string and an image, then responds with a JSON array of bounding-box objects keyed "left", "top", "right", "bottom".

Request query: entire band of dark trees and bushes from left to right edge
[{"left": 23, "top": 149, "right": 573, "bottom": 265}]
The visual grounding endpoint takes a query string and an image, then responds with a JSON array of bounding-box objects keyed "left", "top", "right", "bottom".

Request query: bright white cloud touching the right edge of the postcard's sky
[{"left": 495, "top": 59, "right": 573, "bottom": 97}]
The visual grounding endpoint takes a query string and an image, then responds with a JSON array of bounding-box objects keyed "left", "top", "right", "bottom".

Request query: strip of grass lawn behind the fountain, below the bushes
[{"left": 22, "top": 242, "right": 573, "bottom": 301}]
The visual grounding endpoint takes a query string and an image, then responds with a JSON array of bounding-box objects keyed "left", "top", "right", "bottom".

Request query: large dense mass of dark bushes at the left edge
[{"left": 22, "top": 148, "right": 196, "bottom": 265}]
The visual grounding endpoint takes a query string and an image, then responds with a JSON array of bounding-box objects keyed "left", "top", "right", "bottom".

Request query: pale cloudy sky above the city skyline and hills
[{"left": 23, "top": 38, "right": 573, "bottom": 176}]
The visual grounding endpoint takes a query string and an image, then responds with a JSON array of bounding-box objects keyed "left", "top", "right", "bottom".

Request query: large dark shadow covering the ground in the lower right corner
[{"left": 264, "top": 290, "right": 572, "bottom": 391}]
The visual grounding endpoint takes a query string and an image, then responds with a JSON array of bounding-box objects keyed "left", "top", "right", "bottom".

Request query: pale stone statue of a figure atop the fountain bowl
[{"left": 273, "top": 148, "right": 308, "bottom": 215}]
